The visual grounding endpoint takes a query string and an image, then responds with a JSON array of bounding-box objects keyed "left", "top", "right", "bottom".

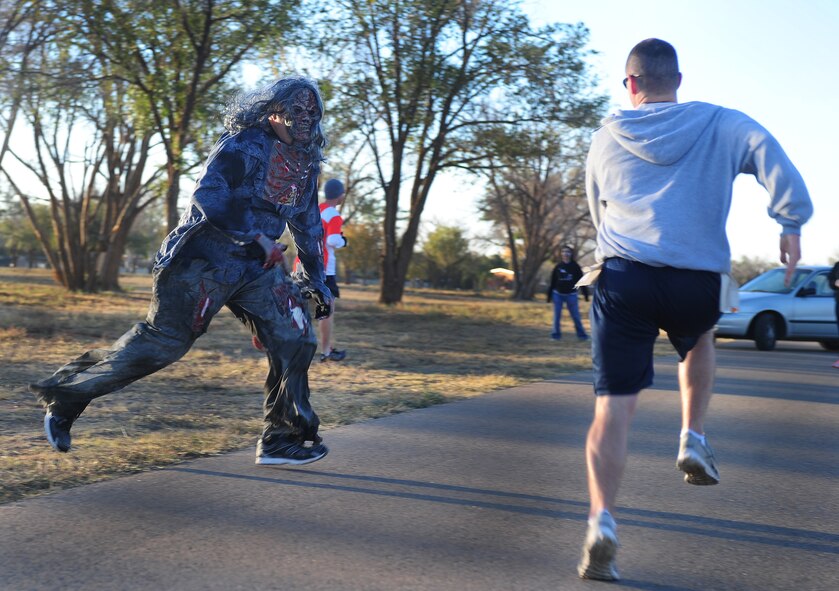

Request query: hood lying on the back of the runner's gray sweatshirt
[{"left": 603, "top": 102, "right": 723, "bottom": 166}]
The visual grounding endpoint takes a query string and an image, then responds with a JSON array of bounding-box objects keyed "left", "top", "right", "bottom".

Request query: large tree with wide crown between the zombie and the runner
[{"left": 322, "top": 0, "right": 601, "bottom": 304}]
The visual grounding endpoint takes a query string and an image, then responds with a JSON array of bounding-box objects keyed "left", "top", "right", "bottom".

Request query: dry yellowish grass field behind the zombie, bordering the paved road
[{"left": 0, "top": 269, "right": 624, "bottom": 503}]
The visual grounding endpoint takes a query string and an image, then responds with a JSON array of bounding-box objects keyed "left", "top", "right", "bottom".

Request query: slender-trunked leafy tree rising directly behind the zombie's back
[{"left": 65, "top": 0, "right": 299, "bottom": 229}]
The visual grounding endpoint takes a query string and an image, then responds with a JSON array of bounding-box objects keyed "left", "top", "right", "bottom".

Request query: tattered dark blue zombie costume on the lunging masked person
[{"left": 30, "top": 79, "right": 331, "bottom": 463}]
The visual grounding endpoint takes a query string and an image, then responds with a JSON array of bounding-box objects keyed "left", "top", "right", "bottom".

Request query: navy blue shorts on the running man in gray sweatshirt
[{"left": 590, "top": 258, "right": 720, "bottom": 396}]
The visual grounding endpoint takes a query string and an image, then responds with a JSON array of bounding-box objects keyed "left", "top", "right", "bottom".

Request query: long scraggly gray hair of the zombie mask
[{"left": 224, "top": 76, "right": 326, "bottom": 161}]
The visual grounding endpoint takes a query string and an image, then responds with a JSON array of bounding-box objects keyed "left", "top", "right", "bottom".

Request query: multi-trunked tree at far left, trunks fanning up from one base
[{"left": 2, "top": 25, "right": 158, "bottom": 291}]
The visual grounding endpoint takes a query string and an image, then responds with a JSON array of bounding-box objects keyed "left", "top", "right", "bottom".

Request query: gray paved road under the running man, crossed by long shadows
[{"left": 0, "top": 343, "right": 839, "bottom": 591}]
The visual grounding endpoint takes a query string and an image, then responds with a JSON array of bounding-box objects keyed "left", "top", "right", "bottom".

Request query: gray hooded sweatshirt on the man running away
[{"left": 586, "top": 102, "right": 813, "bottom": 273}]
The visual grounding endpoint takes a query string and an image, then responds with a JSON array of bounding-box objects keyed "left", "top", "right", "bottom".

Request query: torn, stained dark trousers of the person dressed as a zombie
[{"left": 30, "top": 233, "right": 320, "bottom": 442}]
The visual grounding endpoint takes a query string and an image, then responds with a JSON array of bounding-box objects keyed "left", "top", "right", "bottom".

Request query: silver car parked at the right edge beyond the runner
[{"left": 716, "top": 266, "right": 839, "bottom": 351}]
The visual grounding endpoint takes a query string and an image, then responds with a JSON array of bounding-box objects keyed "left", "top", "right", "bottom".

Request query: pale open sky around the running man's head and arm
[{"left": 428, "top": 0, "right": 839, "bottom": 264}]
